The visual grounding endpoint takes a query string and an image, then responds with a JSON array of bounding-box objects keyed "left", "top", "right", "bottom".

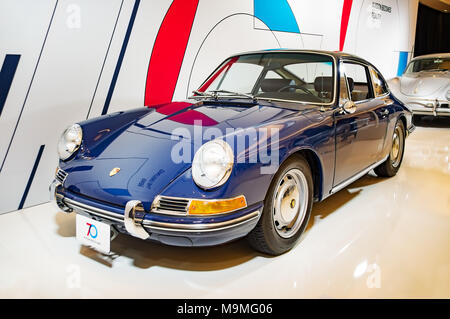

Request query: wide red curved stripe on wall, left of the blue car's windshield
[{"left": 144, "top": 0, "right": 198, "bottom": 106}]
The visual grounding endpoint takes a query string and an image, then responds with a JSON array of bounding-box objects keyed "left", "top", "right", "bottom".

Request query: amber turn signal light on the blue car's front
[{"left": 188, "top": 195, "right": 247, "bottom": 215}]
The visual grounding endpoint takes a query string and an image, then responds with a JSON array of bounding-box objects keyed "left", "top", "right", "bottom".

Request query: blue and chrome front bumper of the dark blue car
[{"left": 50, "top": 181, "right": 262, "bottom": 246}]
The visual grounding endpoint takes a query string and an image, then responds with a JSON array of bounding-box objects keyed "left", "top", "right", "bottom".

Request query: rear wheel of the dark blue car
[{"left": 374, "top": 120, "right": 405, "bottom": 177}]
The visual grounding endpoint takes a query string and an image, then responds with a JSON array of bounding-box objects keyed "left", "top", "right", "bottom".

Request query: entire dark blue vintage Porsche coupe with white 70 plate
[{"left": 51, "top": 50, "right": 414, "bottom": 255}]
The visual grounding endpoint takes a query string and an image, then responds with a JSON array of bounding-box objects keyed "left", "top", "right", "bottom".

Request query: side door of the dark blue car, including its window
[{"left": 333, "top": 61, "right": 387, "bottom": 187}]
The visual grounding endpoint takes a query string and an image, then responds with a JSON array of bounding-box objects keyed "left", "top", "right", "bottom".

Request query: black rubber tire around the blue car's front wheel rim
[{"left": 247, "top": 155, "right": 314, "bottom": 256}]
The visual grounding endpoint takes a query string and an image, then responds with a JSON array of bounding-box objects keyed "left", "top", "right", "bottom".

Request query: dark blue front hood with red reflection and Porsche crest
[{"left": 60, "top": 102, "right": 304, "bottom": 208}]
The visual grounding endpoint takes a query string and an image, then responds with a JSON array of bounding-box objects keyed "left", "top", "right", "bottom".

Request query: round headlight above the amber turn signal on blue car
[{"left": 192, "top": 139, "right": 234, "bottom": 189}]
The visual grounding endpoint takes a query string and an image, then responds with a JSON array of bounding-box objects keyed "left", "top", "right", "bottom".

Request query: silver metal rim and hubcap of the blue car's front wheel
[{"left": 273, "top": 168, "right": 308, "bottom": 238}]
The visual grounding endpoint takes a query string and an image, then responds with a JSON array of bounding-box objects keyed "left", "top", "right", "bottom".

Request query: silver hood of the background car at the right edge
[{"left": 400, "top": 71, "right": 450, "bottom": 97}]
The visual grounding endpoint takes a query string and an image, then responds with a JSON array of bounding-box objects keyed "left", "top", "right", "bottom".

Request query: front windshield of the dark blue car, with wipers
[{"left": 194, "top": 52, "right": 334, "bottom": 104}]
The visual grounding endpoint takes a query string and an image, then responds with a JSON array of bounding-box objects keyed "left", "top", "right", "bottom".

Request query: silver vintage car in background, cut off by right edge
[{"left": 388, "top": 53, "right": 450, "bottom": 116}]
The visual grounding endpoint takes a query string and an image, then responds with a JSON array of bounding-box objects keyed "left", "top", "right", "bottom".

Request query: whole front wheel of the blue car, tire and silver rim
[{"left": 247, "top": 155, "right": 314, "bottom": 255}]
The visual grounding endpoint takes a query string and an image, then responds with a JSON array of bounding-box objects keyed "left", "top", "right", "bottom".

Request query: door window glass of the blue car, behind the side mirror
[{"left": 344, "top": 62, "right": 373, "bottom": 102}]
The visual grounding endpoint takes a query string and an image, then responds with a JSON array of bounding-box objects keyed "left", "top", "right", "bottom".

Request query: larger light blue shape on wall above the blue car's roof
[{"left": 253, "top": 0, "right": 300, "bottom": 33}]
